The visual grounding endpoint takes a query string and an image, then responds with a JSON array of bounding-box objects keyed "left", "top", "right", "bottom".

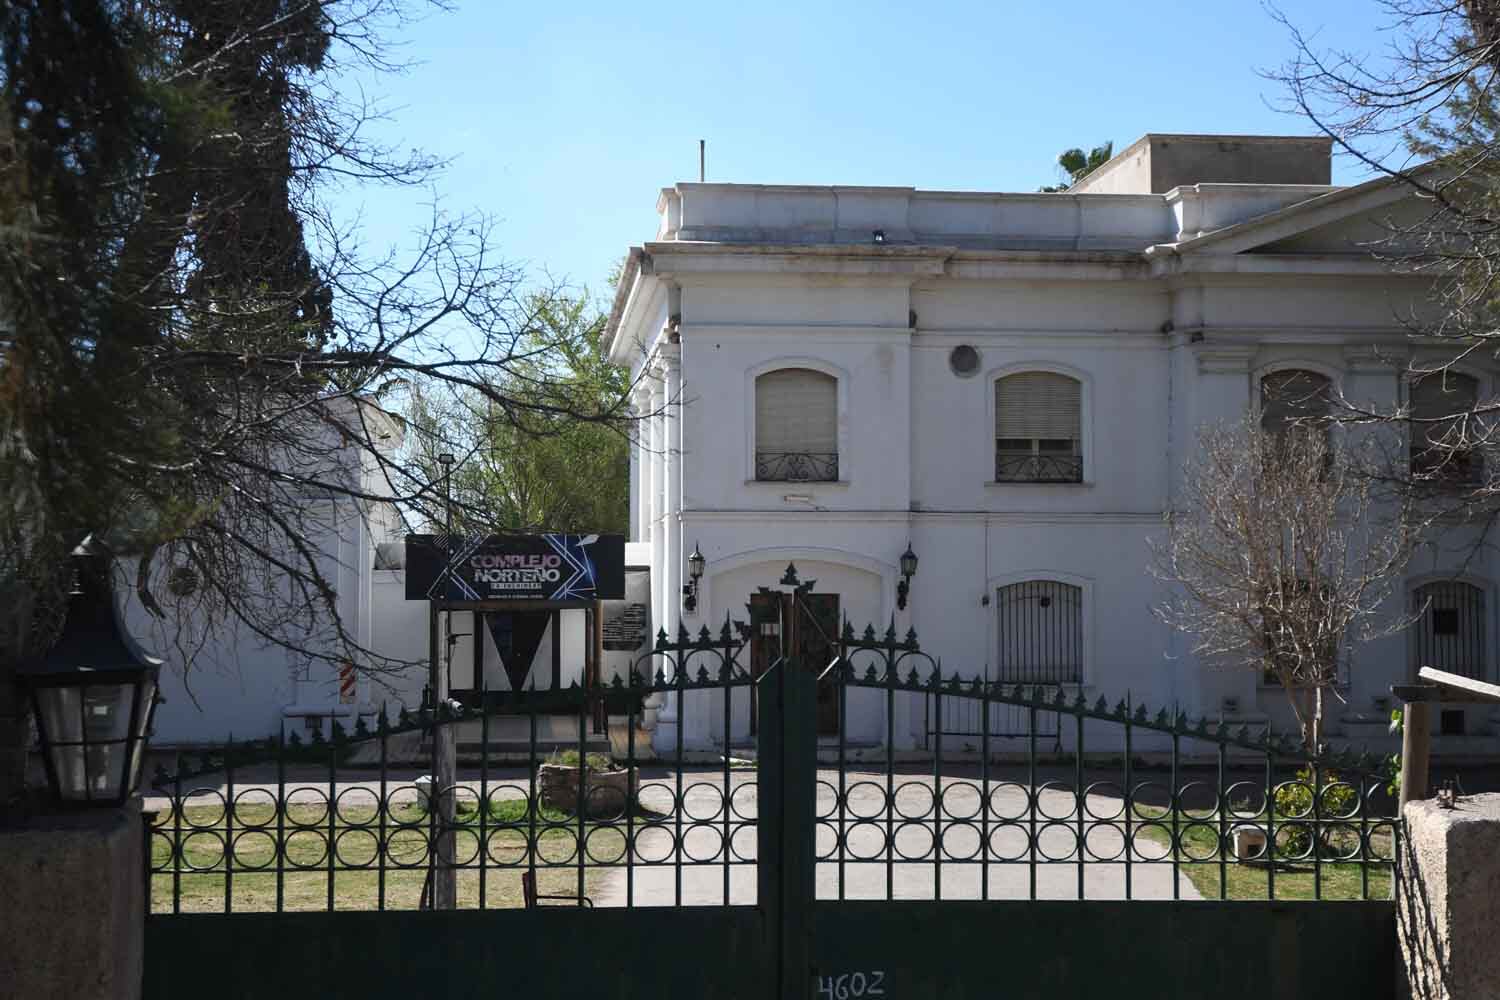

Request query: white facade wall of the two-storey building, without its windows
[{"left": 620, "top": 176, "right": 1500, "bottom": 747}]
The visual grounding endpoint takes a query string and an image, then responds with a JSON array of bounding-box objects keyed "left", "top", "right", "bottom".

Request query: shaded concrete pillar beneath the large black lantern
[{"left": 0, "top": 799, "right": 146, "bottom": 1000}]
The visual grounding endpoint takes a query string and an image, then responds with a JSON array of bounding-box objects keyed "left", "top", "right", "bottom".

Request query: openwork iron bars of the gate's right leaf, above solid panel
[{"left": 798, "top": 611, "right": 1400, "bottom": 900}]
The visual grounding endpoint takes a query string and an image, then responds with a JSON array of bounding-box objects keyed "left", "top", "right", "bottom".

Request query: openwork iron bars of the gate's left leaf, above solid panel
[{"left": 147, "top": 622, "right": 756, "bottom": 913}]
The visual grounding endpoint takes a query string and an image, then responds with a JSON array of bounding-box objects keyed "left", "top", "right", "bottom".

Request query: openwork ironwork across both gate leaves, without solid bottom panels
[{"left": 149, "top": 587, "right": 1398, "bottom": 913}]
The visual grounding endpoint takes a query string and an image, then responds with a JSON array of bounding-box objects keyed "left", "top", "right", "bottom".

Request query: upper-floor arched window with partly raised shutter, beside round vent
[{"left": 995, "top": 372, "right": 1083, "bottom": 483}]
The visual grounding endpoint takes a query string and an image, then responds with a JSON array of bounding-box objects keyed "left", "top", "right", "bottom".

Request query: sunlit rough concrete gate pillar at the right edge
[{"left": 1397, "top": 793, "right": 1500, "bottom": 1000}]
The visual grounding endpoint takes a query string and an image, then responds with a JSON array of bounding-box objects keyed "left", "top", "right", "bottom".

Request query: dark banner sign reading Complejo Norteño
[{"left": 407, "top": 535, "right": 626, "bottom": 601}]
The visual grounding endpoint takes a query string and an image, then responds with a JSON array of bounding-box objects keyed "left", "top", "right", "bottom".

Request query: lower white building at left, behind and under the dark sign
[{"left": 136, "top": 395, "right": 650, "bottom": 747}]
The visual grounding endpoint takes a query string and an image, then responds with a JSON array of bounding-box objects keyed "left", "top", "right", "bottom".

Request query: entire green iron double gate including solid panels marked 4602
[{"left": 146, "top": 567, "right": 1398, "bottom": 1000}]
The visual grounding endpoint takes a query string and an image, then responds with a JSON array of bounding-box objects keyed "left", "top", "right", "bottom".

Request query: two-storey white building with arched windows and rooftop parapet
[{"left": 603, "top": 135, "right": 1500, "bottom": 750}]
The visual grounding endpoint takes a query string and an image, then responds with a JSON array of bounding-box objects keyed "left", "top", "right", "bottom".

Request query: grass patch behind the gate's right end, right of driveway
[{"left": 1136, "top": 805, "right": 1395, "bottom": 900}]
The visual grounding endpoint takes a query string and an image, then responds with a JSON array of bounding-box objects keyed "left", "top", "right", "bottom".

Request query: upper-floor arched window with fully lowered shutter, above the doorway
[{"left": 755, "top": 367, "right": 839, "bottom": 483}]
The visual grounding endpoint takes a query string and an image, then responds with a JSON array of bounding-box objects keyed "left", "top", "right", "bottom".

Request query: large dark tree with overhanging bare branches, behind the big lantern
[{"left": 0, "top": 0, "right": 639, "bottom": 819}]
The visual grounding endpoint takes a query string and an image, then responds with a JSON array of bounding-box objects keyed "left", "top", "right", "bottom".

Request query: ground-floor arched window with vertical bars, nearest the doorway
[{"left": 996, "top": 580, "right": 1083, "bottom": 684}]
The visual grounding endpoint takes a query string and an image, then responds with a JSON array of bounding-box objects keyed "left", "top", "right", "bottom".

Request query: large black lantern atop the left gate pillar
[{"left": 17, "top": 537, "right": 162, "bottom": 807}]
